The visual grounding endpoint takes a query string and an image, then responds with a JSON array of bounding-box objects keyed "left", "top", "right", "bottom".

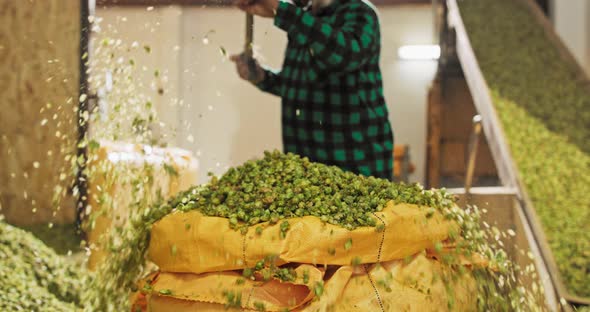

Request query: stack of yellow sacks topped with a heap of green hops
[{"left": 131, "top": 152, "right": 493, "bottom": 312}]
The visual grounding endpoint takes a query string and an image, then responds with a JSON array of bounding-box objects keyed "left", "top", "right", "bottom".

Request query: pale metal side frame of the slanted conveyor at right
[{"left": 445, "top": 0, "right": 590, "bottom": 311}]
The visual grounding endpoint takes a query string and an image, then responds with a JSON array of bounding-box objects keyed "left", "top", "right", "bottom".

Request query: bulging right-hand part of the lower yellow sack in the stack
[{"left": 314, "top": 254, "right": 477, "bottom": 312}]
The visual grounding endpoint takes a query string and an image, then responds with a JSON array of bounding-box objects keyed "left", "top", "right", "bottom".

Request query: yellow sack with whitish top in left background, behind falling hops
[{"left": 86, "top": 141, "right": 198, "bottom": 270}]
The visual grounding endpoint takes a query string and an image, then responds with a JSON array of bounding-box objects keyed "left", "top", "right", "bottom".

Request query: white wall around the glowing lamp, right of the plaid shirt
[{"left": 379, "top": 6, "right": 437, "bottom": 183}]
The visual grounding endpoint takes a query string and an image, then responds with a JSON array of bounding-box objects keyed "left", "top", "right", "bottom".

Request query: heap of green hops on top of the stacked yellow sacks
[{"left": 172, "top": 151, "right": 452, "bottom": 230}]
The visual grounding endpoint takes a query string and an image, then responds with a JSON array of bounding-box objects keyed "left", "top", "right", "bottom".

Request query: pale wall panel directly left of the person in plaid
[{"left": 179, "top": 7, "right": 286, "bottom": 177}]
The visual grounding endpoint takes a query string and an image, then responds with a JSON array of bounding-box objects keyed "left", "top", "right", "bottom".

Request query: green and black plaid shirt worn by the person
[{"left": 258, "top": 0, "right": 393, "bottom": 180}]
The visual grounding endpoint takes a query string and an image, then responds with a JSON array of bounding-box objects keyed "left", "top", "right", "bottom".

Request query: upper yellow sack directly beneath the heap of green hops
[{"left": 148, "top": 202, "right": 459, "bottom": 274}]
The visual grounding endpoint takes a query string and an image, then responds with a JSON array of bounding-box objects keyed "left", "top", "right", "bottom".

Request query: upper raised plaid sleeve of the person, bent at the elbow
[{"left": 274, "top": 1, "right": 378, "bottom": 73}]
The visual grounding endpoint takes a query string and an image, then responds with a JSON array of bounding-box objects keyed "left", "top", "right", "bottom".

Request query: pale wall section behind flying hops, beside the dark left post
[{"left": 95, "top": 6, "right": 183, "bottom": 141}]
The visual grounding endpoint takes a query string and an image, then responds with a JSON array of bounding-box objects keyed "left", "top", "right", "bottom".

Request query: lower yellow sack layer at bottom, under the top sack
[{"left": 132, "top": 254, "right": 477, "bottom": 312}]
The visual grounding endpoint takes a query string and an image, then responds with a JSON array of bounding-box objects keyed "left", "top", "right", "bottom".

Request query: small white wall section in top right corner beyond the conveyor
[{"left": 552, "top": 0, "right": 590, "bottom": 76}]
